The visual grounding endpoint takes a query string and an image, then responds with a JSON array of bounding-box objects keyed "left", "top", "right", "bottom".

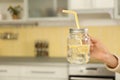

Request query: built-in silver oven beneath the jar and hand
[{"left": 69, "top": 64, "right": 115, "bottom": 80}]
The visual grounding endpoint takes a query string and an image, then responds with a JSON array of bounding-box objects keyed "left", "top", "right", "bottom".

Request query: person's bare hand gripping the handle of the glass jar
[{"left": 90, "top": 37, "right": 118, "bottom": 68}]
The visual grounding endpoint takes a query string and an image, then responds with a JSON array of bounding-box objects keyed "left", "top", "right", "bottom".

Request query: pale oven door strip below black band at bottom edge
[{"left": 70, "top": 77, "right": 114, "bottom": 80}]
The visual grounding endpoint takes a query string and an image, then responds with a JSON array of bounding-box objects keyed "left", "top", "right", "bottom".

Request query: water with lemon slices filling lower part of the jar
[{"left": 67, "top": 45, "right": 89, "bottom": 64}]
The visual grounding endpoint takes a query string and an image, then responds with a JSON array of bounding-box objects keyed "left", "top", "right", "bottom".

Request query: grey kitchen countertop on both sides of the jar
[{"left": 0, "top": 57, "right": 103, "bottom": 64}]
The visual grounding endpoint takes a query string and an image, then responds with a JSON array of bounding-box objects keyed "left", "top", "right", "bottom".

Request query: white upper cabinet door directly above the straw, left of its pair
[{"left": 69, "top": 0, "right": 92, "bottom": 10}]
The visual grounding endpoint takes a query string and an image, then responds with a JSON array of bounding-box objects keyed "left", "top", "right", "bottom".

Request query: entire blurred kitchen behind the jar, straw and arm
[{"left": 0, "top": 0, "right": 120, "bottom": 80}]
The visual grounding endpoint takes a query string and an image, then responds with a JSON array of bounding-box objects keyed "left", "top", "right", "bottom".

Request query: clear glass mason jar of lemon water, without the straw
[{"left": 67, "top": 28, "right": 90, "bottom": 64}]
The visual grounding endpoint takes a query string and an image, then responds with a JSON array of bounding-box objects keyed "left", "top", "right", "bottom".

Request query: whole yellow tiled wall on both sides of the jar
[{"left": 0, "top": 26, "right": 120, "bottom": 57}]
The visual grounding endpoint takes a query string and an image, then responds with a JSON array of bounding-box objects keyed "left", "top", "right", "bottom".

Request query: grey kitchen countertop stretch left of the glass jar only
[{"left": 0, "top": 57, "right": 68, "bottom": 65}]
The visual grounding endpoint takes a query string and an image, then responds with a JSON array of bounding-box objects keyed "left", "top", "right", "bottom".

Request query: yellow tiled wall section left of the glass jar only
[{"left": 0, "top": 26, "right": 68, "bottom": 57}]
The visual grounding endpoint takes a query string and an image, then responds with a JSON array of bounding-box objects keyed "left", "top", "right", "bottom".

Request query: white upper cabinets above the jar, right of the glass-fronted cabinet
[{"left": 69, "top": 0, "right": 114, "bottom": 17}]
